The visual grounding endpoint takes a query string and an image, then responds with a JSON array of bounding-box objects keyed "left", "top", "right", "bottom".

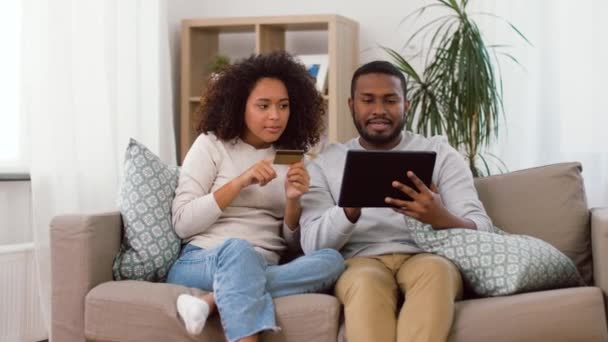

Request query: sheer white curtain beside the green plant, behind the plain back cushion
[{"left": 473, "top": 0, "right": 608, "bottom": 206}]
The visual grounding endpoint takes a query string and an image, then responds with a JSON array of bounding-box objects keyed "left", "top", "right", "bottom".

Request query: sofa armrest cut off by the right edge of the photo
[{"left": 591, "top": 207, "right": 608, "bottom": 303}]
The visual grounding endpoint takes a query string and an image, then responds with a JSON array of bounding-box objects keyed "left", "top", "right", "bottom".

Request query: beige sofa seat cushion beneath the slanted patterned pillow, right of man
[{"left": 448, "top": 287, "right": 608, "bottom": 342}]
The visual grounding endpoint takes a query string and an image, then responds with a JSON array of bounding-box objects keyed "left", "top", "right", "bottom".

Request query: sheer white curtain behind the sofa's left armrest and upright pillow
[{"left": 22, "top": 0, "right": 175, "bottom": 334}]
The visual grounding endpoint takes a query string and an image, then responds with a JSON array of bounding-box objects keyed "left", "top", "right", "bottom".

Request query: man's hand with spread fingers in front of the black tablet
[{"left": 385, "top": 171, "right": 476, "bottom": 229}]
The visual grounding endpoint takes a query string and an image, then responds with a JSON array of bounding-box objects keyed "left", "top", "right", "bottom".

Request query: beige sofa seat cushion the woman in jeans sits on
[{"left": 85, "top": 280, "right": 340, "bottom": 342}]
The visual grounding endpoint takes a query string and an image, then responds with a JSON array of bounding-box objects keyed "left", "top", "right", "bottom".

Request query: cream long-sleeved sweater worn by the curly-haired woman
[{"left": 173, "top": 133, "right": 299, "bottom": 264}]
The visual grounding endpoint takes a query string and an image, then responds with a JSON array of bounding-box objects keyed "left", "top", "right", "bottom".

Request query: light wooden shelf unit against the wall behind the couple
[{"left": 179, "top": 15, "right": 359, "bottom": 164}]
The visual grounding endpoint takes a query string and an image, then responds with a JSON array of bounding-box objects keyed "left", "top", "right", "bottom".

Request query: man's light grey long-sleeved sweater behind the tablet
[{"left": 300, "top": 132, "right": 493, "bottom": 258}]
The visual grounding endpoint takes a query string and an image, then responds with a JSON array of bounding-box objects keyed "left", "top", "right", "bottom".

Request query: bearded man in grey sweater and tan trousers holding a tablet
[{"left": 300, "top": 61, "right": 492, "bottom": 342}]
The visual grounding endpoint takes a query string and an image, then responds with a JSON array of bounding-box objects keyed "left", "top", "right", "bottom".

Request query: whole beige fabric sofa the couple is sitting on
[{"left": 50, "top": 163, "right": 608, "bottom": 342}]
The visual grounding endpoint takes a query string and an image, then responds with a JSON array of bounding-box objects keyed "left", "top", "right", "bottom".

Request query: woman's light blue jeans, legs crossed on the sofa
[{"left": 167, "top": 239, "right": 344, "bottom": 342}]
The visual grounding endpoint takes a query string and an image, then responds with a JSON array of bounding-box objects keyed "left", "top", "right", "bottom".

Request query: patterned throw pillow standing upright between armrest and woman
[{"left": 112, "top": 139, "right": 181, "bottom": 281}]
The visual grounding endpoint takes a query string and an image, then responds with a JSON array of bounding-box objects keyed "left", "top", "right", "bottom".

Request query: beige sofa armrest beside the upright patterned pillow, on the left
[{"left": 50, "top": 212, "right": 122, "bottom": 342}]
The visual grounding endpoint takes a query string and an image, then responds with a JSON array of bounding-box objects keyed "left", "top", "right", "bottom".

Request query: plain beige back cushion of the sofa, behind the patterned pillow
[{"left": 475, "top": 163, "right": 592, "bottom": 284}]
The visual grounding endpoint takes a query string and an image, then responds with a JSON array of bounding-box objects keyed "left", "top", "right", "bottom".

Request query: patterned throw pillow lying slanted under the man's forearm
[{"left": 408, "top": 219, "right": 583, "bottom": 296}]
